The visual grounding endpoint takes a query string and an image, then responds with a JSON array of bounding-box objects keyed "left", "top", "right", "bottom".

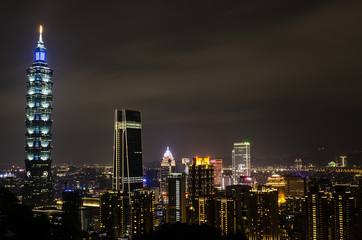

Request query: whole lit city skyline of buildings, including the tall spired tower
[{"left": 0, "top": 26, "right": 362, "bottom": 240}]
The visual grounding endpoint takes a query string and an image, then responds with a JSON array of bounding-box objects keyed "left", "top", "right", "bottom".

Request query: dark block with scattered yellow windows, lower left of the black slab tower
[{"left": 99, "top": 191, "right": 125, "bottom": 239}]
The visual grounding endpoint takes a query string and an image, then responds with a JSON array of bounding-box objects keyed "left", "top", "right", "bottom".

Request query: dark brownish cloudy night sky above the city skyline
[{"left": 0, "top": 0, "right": 362, "bottom": 165}]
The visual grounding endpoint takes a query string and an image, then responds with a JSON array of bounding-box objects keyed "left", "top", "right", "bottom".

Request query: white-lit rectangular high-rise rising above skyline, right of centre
[{"left": 232, "top": 142, "right": 250, "bottom": 184}]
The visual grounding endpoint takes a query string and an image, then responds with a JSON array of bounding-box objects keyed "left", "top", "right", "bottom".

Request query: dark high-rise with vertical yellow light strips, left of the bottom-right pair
[{"left": 306, "top": 181, "right": 332, "bottom": 240}]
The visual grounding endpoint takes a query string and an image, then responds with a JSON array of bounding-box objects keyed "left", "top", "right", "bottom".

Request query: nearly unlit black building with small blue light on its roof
[{"left": 62, "top": 189, "right": 82, "bottom": 239}]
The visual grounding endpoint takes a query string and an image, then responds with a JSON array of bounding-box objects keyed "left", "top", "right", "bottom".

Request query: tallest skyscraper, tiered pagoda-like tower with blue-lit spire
[{"left": 23, "top": 26, "right": 53, "bottom": 206}]
